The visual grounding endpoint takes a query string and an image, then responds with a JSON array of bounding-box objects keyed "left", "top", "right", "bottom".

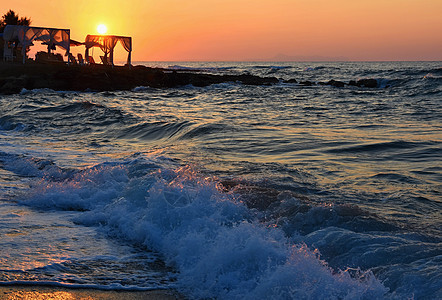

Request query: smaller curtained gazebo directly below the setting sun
[{"left": 84, "top": 35, "right": 132, "bottom": 66}]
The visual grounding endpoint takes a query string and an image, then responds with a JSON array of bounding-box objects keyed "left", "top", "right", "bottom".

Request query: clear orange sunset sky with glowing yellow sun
[{"left": 0, "top": 0, "right": 442, "bottom": 61}]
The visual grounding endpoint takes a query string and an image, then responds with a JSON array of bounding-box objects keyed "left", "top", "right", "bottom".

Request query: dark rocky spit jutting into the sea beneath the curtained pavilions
[{"left": 0, "top": 62, "right": 378, "bottom": 94}]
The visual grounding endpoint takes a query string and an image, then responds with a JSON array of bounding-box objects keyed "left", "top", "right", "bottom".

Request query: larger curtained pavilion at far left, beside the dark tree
[{"left": 3, "top": 25, "right": 71, "bottom": 63}]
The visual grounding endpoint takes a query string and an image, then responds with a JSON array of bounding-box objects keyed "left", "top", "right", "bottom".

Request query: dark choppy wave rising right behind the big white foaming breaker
[{"left": 223, "top": 181, "right": 400, "bottom": 236}]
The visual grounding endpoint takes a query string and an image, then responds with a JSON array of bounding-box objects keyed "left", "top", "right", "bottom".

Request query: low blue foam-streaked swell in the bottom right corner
[{"left": 306, "top": 227, "right": 440, "bottom": 299}]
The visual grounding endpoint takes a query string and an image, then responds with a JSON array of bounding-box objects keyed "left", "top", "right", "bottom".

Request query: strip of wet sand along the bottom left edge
[{"left": 0, "top": 285, "right": 184, "bottom": 300}]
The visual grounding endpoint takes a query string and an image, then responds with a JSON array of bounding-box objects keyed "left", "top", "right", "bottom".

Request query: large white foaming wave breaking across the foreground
[{"left": 6, "top": 159, "right": 387, "bottom": 299}]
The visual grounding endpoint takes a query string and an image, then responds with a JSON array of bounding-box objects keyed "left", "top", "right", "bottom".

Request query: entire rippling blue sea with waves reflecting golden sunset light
[{"left": 0, "top": 62, "right": 442, "bottom": 299}]
